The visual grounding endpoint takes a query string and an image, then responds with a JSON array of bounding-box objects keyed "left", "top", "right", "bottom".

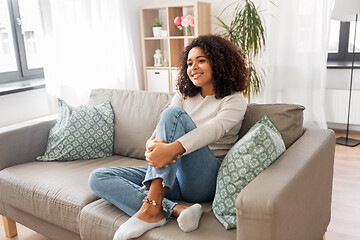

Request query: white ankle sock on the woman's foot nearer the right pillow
[{"left": 177, "top": 203, "right": 203, "bottom": 232}]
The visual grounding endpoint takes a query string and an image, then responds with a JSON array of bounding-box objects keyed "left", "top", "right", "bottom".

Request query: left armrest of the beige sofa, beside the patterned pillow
[{"left": 0, "top": 115, "right": 56, "bottom": 170}]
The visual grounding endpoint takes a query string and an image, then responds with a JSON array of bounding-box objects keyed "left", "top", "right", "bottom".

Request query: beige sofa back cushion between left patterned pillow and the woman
[{"left": 89, "top": 89, "right": 173, "bottom": 159}]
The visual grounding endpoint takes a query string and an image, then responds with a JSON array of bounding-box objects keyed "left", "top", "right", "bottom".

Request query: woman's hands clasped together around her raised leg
[{"left": 145, "top": 139, "right": 185, "bottom": 168}]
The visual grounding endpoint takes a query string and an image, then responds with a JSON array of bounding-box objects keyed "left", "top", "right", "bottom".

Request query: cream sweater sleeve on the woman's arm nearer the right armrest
[{"left": 177, "top": 96, "right": 247, "bottom": 155}]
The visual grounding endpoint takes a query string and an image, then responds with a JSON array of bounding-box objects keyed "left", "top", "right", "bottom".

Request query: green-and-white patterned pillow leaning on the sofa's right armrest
[{"left": 213, "top": 115, "right": 285, "bottom": 229}]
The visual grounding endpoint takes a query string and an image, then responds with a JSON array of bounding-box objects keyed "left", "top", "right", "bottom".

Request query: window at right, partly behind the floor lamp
[{"left": 328, "top": 20, "right": 360, "bottom": 65}]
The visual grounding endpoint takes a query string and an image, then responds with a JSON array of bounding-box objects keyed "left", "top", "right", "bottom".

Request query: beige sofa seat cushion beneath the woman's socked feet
[{"left": 80, "top": 199, "right": 236, "bottom": 240}]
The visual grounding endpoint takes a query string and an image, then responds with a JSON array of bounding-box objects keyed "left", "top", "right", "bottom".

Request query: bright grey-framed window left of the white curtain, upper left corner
[{"left": 0, "top": 0, "right": 44, "bottom": 83}]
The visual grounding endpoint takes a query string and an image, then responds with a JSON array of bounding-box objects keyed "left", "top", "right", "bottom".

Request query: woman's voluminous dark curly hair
[{"left": 177, "top": 35, "right": 248, "bottom": 98}]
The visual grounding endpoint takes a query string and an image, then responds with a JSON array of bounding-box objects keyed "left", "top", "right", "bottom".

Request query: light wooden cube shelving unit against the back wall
[{"left": 140, "top": 2, "right": 211, "bottom": 92}]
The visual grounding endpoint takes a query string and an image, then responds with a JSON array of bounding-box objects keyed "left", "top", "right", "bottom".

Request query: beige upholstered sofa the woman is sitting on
[{"left": 0, "top": 89, "right": 335, "bottom": 240}]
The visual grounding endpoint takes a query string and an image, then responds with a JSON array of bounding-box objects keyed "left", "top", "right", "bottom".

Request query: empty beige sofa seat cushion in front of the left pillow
[{"left": 0, "top": 156, "right": 146, "bottom": 233}]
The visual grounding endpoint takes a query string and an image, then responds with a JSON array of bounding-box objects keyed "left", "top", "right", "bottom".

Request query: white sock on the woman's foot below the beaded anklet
[{"left": 113, "top": 216, "right": 166, "bottom": 240}]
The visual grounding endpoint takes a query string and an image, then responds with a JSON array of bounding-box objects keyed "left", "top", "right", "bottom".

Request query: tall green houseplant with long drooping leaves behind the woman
[{"left": 217, "top": 0, "right": 271, "bottom": 103}]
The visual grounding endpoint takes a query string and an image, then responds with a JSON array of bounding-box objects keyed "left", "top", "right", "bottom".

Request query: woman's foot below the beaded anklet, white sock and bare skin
[{"left": 113, "top": 203, "right": 166, "bottom": 240}]
